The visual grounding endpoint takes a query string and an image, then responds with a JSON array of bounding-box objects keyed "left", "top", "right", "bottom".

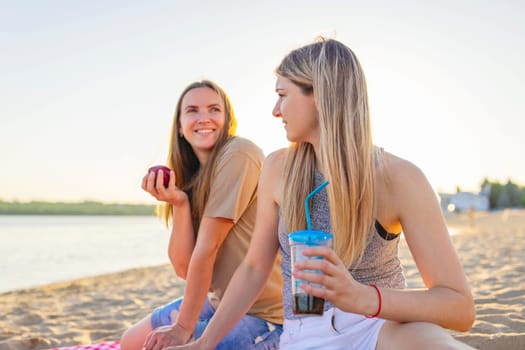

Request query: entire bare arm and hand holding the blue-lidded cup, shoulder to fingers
[{"left": 293, "top": 157, "right": 475, "bottom": 331}]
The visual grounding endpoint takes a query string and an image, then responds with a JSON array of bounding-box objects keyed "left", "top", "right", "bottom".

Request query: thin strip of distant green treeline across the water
[{"left": 0, "top": 200, "right": 155, "bottom": 215}]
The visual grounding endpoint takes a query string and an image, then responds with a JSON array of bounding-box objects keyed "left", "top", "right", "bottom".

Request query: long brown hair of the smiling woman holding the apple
[{"left": 157, "top": 80, "right": 237, "bottom": 232}]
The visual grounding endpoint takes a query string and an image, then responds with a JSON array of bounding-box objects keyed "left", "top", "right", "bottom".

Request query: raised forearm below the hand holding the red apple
[{"left": 168, "top": 204, "right": 195, "bottom": 279}]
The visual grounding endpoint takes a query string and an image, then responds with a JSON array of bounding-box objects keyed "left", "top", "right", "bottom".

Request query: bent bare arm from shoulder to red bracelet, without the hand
[{"left": 381, "top": 160, "right": 475, "bottom": 331}]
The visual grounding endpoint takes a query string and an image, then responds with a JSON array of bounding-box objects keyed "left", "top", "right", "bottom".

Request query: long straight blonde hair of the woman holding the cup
[{"left": 276, "top": 38, "right": 375, "bottom": 266}]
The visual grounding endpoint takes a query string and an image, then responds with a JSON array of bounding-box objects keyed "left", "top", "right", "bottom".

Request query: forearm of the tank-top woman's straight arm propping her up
[{"left": 195, "top": 260, "right": 271, "bottom": 349}]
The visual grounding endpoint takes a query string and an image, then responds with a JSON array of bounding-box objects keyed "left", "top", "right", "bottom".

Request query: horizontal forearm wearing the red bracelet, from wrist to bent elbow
[{"left": 361, "top": 287, "right": 475, "bottom": 331}]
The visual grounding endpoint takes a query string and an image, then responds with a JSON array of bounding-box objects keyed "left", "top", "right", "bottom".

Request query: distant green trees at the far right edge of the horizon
[{"left": 481, "top": 179, "right": 525, "bottom": 209}]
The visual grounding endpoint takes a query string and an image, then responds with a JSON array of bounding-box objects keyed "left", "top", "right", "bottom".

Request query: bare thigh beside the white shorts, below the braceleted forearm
[{"left": 376, "top": 321, "right": 474, "bottom": 350}]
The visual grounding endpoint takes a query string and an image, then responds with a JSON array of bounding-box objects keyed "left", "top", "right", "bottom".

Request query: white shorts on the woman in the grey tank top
[{"left": 280, "top": 308, "right": 385, "bottom": 350}]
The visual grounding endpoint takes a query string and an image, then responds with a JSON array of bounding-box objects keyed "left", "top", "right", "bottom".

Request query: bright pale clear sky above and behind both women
[{"left": 0, "top": 0, "right": 525, "bottom": 203}]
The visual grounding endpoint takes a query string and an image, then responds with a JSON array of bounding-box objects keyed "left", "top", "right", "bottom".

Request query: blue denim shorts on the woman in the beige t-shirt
[{"left": 151, "top": 298, "right": 283, "bottom": 350}]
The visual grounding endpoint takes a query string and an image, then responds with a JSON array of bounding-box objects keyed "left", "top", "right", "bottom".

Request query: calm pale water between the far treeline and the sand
[{"left": 0, "top": 215, "right": 169, "bottom": 293}]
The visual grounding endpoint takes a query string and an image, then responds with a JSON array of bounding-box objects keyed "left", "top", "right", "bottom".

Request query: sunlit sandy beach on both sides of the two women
[{"left": 0, "top": 210, "right": 525, "bottom": 350}]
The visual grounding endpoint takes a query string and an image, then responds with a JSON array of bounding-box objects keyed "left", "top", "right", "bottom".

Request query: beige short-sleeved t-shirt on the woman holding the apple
[{"left": 203, "top": 137, "right": 283, "bottom": 324}]
